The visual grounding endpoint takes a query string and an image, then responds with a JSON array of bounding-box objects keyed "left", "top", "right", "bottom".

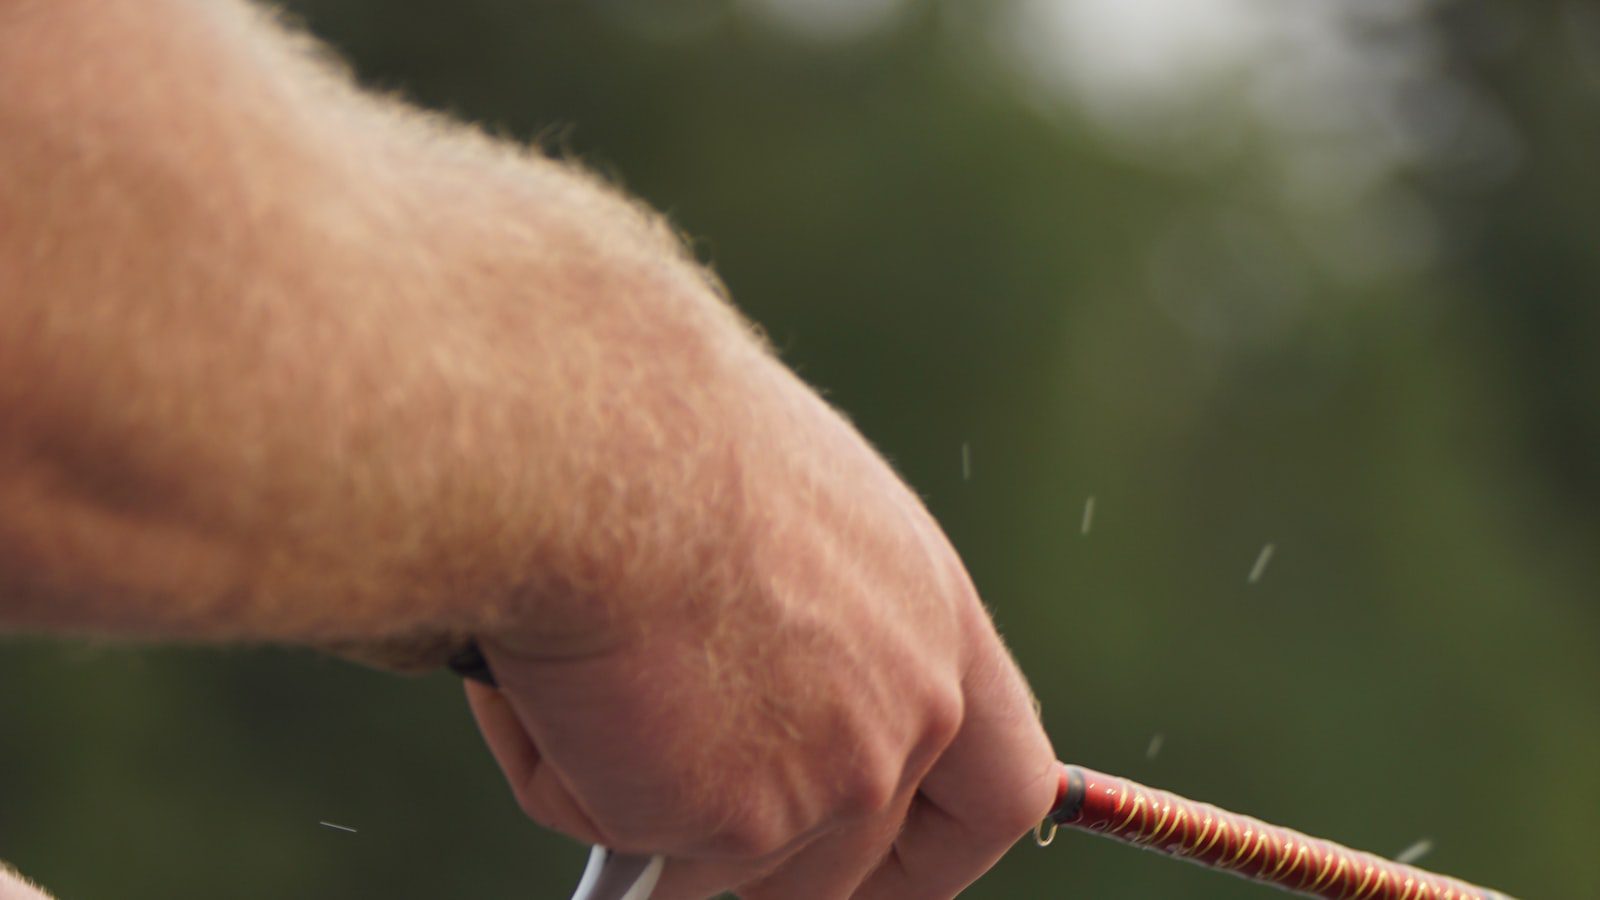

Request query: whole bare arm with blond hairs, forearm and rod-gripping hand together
[{"left": 0, "top": 0, "right": 1056, "bottom": 900}]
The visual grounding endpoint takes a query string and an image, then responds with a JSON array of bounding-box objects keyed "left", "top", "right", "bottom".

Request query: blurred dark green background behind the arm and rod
[{"left": 0, "top": 0, "right": 1600, "bottom": 900}]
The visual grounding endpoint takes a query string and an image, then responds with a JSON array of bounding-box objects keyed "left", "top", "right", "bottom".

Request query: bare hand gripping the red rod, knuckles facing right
[{"left": 467, "top": 353, "right": 1056, "bottom": 900}]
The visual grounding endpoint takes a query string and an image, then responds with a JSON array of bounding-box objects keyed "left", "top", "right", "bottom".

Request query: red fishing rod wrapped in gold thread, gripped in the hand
[{"left": 450, "top": 644, "right": 1512, "bottom": 900}]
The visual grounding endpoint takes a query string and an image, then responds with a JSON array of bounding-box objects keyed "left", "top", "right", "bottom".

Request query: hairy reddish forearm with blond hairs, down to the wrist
[{"left": 0, "top": 0, "right": 768, "bottom": 659}]
